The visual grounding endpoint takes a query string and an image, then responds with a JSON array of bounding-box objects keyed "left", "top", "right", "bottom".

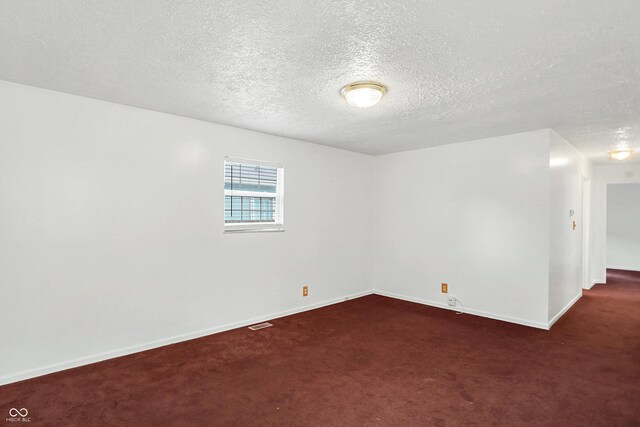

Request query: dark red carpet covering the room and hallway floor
[{"left": 0, "top": 270, "right": 640, "bottom": 427}]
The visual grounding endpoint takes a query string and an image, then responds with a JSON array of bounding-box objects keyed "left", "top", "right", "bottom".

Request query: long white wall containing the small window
[{"left": 0, "top": 81, "right": 373, "bottom": 383}]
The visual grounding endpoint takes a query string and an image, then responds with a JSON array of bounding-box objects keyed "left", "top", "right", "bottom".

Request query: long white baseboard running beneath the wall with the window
[{"left": 0, "top": 291, "right": 373, "bottom": 386}]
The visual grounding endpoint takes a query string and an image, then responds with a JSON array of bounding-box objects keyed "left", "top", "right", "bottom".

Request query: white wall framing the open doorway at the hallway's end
[{"left": 589, "top": 166, "right": 640, "bottom": 285}]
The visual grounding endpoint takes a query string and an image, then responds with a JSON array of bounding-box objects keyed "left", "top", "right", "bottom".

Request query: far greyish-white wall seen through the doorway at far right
[{"left": 607, "top": 184, "right": 640, "bottom": 271}]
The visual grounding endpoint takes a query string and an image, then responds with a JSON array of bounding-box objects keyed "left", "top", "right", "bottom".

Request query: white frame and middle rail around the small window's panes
[{"left": 222, "top": 156, "right": 284, "bottom": 233}]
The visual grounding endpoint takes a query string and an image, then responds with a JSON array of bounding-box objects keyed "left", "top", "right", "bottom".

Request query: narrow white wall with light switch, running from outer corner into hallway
[{"left": 549, "top": 132, "right": 588, "bottom": 320}]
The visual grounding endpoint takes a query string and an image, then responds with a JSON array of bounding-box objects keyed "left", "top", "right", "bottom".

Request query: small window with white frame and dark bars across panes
[{"left": 224, "top": 157, "right": 284, "bottom": 232}]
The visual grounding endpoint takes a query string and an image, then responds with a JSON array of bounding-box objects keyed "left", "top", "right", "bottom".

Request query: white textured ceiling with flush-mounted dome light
[{"left": 0, "top": 0, "right": 640, "bottom": 161}]
